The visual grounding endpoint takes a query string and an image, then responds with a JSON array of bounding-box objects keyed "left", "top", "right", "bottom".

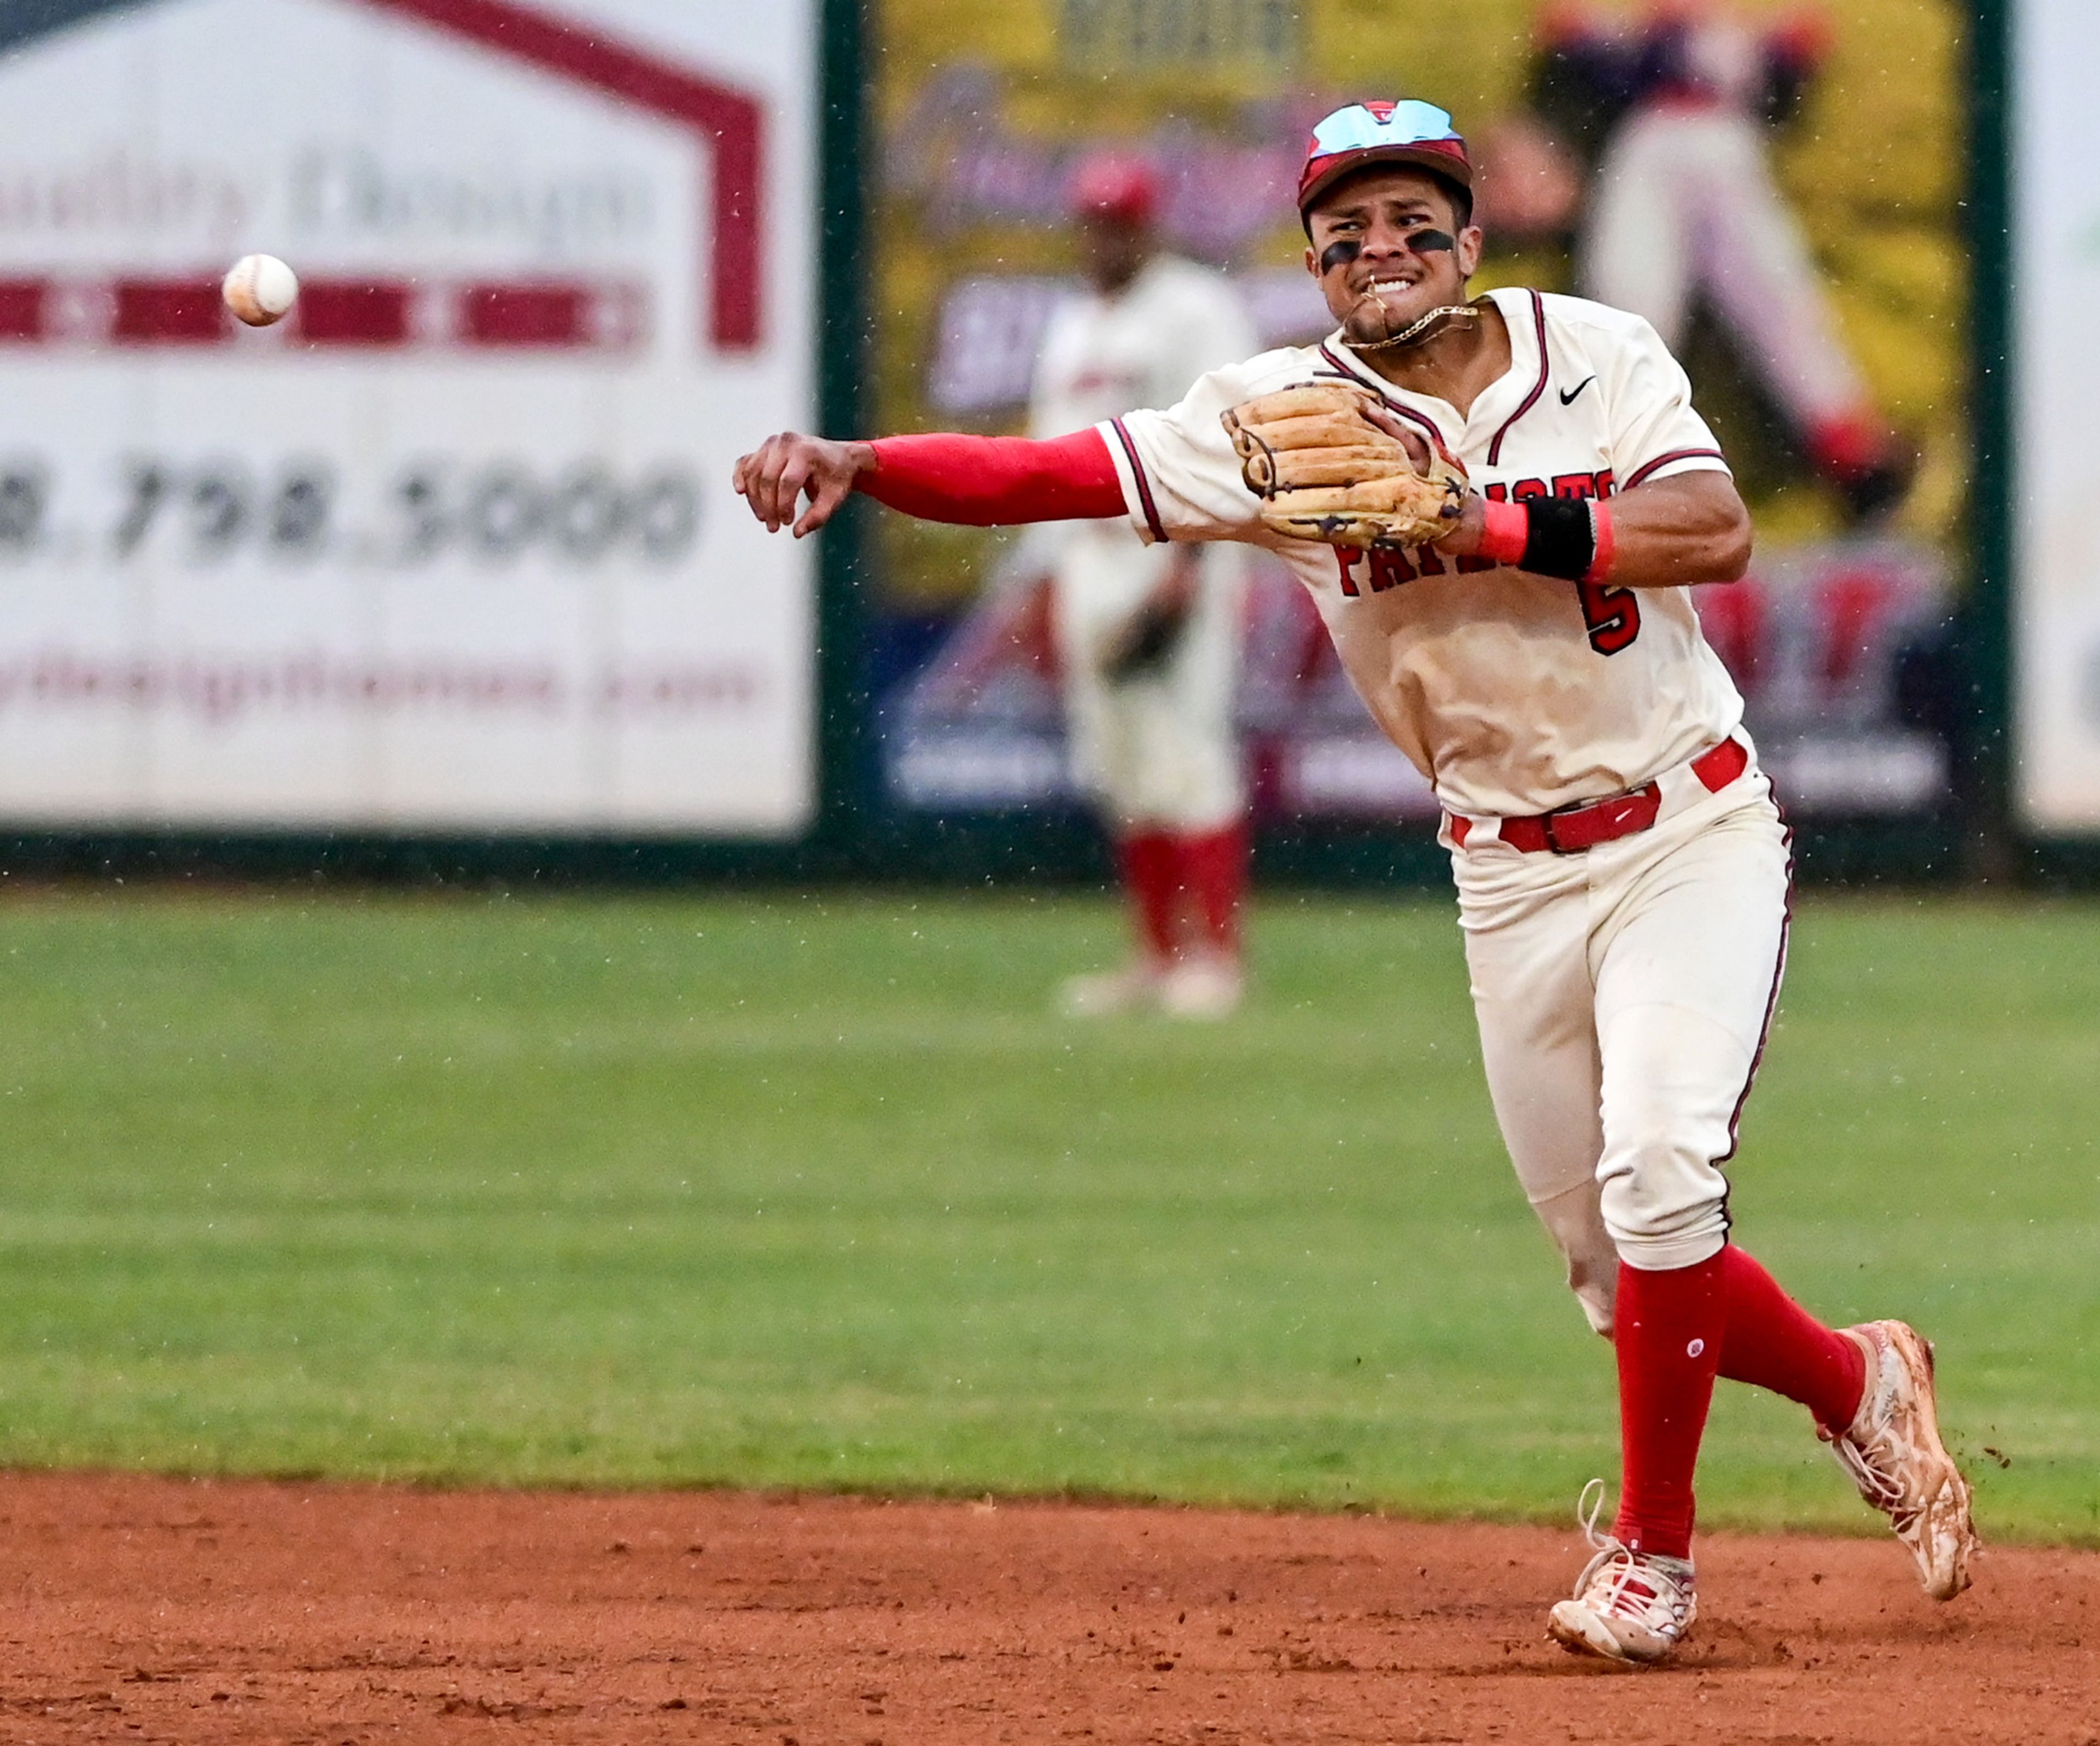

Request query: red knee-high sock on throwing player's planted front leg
[{"left": 1611, "top": 1250, "right": 1728, "bottom": 1559}]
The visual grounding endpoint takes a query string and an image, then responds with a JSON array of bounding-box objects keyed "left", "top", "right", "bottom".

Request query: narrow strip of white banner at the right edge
[{"left": 2012, "top": 0, "right": 2100, "bottom": 830}]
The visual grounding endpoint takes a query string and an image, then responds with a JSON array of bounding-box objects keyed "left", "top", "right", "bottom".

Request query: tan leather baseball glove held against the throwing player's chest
[{"left": 1220, "top": 382, "right": 1466, "bottom": 546}]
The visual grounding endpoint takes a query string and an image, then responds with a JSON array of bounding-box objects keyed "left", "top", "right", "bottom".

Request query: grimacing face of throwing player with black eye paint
[{"left": 1306, "top": 164, "right": 1480, "bottom": 340}]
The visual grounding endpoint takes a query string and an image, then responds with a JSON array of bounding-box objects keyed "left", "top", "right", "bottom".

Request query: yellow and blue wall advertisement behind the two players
[{"left": 873, "top": 0, "right": 1965, "bottom": 828}]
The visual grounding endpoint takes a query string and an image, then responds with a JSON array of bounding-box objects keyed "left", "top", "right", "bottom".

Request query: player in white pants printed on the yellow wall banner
[{"left": 1497, "top": 0, "right": 1915, "bottom": 521}]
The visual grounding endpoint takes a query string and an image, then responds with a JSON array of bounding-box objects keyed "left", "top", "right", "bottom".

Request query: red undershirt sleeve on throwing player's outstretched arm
[{"left": 853, "top": 429, "right": 1123, "bottom": 527}]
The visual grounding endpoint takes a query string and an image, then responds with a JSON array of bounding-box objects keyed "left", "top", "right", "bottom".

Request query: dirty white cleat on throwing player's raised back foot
[{"left": 1817, "top": 1322, "right": 1982, "bottom": 1601}]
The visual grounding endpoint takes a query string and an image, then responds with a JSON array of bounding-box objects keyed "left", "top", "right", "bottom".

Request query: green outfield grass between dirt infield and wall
[{"left": 0, "top": 893, "right": 2100, "bottom": 1540}]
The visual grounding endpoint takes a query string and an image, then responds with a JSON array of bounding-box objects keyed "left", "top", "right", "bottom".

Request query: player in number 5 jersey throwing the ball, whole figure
[{"left": 735, "top": 103, "right": 1976, "bottom": 1662}]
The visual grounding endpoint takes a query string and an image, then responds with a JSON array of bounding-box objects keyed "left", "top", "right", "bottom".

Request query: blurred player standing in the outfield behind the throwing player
[{"left": 1029, "top": 153, "right": 1258, "bottom": 1017}]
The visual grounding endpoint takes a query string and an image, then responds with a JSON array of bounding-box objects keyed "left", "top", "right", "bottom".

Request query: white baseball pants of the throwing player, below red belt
[{"left": 1451, "top": 765, "right": 1792, "bottom": 1334}]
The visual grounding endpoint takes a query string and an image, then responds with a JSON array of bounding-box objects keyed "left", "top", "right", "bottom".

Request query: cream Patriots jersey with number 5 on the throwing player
[{"left": 1098, "top": 290, "right": 1743, "bottom": 817}]
